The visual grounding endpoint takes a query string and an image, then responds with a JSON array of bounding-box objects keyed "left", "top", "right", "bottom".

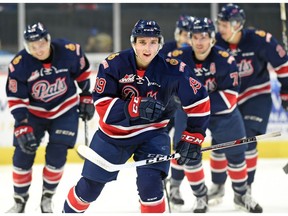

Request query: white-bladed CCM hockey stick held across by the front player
[{"left": 78, "top": 132, "right": 281, "bottom": 172}]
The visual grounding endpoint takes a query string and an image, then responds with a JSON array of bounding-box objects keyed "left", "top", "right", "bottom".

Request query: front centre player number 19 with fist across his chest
[{"left": 63, "top": 20, "right": 210, "bottom": 213}]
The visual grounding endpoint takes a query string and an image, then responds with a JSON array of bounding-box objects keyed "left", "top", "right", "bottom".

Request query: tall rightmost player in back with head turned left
[{"left": 209, "top": 4, "right": 288, "bottom": 210}]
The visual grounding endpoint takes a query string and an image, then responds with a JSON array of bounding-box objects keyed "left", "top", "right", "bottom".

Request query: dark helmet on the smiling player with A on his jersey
[{"left": 189, "top": 17, "right": 215, "bottom": 39}]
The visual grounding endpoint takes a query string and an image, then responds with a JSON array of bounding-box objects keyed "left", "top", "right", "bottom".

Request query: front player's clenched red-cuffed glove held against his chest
[{"left": 126, "top": 97, "right": 165, "bottom": 122}]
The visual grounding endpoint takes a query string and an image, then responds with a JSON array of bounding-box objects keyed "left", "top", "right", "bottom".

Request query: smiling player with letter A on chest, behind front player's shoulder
[{"left": 171, "top": 18, "right": 262, "bottom": 213}]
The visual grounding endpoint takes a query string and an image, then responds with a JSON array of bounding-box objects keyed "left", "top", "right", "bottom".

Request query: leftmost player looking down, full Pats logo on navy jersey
[{"left": 6, "top": 22, "right": 95, "bottom": 213}]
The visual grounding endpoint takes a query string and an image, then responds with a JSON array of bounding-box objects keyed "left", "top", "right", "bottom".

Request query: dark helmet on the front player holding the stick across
[{"left": 130, "top": 19, "right": 164, "bottom": 47}]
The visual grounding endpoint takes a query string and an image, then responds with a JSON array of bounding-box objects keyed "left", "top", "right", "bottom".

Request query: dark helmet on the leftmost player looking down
[{"left": 24, "top": 22, "right": 49, "bottom": 42}]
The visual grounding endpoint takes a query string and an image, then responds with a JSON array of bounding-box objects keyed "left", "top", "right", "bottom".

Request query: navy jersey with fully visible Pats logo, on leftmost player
[{"left": 6, "top": 39, "right": 91, "bottom": 121}]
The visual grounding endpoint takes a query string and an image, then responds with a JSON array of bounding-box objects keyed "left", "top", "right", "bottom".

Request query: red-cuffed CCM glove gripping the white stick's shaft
[{"left": 176, "top": 131, "right": 204, "bottom": 165}]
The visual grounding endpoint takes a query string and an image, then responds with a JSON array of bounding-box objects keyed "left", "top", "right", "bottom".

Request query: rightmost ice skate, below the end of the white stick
[{"left": 234, "top": 193, "right": 263, "bottom": 213}]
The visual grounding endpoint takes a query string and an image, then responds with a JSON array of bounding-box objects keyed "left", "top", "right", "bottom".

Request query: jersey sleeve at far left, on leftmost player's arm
[{"left": 6, "top": 56, "right": 29, "bottom": 122}]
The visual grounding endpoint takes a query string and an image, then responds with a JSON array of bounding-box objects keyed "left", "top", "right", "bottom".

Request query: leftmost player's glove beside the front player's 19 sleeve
[{"left": 79, "top": 92, "right": 95, "bottom": 121}]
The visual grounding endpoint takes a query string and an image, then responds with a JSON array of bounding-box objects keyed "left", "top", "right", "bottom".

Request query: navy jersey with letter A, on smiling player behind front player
[{"left": 171, "top": 46, "right": 240, "bottom": 114}]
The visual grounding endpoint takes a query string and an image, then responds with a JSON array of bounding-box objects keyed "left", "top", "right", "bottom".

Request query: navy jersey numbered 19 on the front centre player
[{"left": 93, "top": 49, "right": 210, "bottom": 143}]
